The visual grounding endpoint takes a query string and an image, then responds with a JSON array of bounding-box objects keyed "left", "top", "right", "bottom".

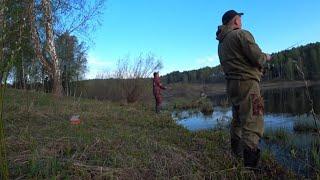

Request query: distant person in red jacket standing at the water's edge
[{"left": 153, "top": 72, "right": 166, "bottom": 113}]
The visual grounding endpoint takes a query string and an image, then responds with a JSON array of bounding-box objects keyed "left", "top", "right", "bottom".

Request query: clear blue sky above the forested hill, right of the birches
[{"left": 86, "top": 0, "right": 320, "bottom": 78}]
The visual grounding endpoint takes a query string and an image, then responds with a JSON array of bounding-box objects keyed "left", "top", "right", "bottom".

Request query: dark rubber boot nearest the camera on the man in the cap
[{"left": 243, "top": 148, "right": 260, "bottom": 168}]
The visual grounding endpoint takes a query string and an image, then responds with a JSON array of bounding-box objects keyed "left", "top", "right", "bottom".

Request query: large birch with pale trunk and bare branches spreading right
[{"left": 29, "top": 0, "right": 105, "bottom": 97}]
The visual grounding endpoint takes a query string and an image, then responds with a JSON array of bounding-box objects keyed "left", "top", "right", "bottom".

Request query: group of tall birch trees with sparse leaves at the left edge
[{"left": 0, "top": 0, "right": 105, "bottom": 97}]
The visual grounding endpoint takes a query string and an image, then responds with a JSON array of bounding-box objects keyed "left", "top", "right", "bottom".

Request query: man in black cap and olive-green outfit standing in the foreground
[{"left": 216, "top": 10, "right": 271, "bottom": 168}]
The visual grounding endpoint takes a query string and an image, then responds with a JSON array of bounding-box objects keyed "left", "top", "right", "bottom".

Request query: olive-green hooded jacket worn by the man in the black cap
[{"left": 217, "top": 25, "right": 267, "bottom": 81}]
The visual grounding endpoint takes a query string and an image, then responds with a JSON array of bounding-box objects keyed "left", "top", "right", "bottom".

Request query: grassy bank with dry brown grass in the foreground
[{"left": 4, "top": 90, "right": 293, "bottom": 179}]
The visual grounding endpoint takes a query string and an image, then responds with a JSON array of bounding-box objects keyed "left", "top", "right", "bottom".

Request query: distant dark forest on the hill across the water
[{"left": 162, "top": 42, "right": 320, "bottom": 84}]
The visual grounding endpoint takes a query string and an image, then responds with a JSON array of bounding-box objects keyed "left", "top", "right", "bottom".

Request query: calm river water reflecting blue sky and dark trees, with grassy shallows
[{"left": 172, "top": 85, "right": 320, "bottom": 178}]
